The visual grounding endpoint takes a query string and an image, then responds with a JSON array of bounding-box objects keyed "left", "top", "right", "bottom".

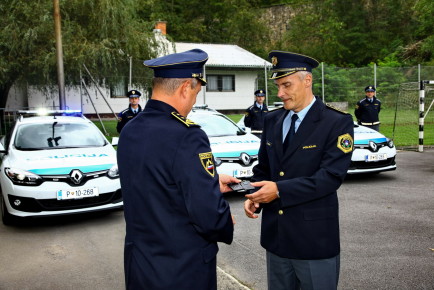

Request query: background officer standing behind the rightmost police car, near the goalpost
[{"left": 354, "top": 86, "right": 381, "bottom": 131}]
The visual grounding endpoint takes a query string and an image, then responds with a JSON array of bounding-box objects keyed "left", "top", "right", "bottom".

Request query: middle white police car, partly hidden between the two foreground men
[{"left": 187, "top": 105, "right": 261, "bottom": 179}]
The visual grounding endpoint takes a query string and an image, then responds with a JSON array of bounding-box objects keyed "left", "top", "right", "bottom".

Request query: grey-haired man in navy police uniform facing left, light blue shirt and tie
[{"left": 244, "top": 51, "right": 354, "bottom": 290}]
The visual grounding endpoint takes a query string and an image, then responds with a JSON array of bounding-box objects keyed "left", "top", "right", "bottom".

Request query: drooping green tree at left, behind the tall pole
[{"left": 0, "top": 0, "right": 155, "bottom": 107}]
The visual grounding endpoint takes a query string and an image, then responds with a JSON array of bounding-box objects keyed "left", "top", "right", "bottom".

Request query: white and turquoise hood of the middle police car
[{"left": 209, "top": 134, "right": 261, "bottom": 157}]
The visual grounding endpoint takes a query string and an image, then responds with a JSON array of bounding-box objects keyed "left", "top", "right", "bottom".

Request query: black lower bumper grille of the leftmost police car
[{"left": 8, "top": 189, "right": 122, "bottom": 212}]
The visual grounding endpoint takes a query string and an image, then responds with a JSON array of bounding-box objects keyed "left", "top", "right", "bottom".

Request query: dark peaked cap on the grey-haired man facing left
[{"left": 268, "top": 50, "right": 319, "bottom": 79}]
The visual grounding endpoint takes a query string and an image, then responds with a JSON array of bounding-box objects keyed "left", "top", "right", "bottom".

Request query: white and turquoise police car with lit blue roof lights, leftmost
[{"left": 0, "top": 111, "right": 123, "bottom": 224}]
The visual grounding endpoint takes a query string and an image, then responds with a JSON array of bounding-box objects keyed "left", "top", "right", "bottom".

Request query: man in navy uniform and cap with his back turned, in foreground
[{"left": 117, "top": 49, "right": 236, "bottom": 289}]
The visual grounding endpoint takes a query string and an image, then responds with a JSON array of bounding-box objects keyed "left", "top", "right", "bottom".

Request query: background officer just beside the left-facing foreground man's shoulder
[{"left": 244, "top": 90, "right": 268, "bottom": 138}]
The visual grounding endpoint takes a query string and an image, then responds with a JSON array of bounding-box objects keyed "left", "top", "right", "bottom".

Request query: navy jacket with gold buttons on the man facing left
[{"left": 253, "top": 98, "right": 354, "bottom": 260}]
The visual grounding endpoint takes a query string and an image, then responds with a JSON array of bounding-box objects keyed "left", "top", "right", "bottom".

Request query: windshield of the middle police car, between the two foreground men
[{"left": 189, "top": 114, "right": 246, "bottom": 137}]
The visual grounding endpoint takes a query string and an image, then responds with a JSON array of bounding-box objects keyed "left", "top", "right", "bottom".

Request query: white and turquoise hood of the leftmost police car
[{"left": 8, "top": 145, "right": 116, "bottom": 175}]
